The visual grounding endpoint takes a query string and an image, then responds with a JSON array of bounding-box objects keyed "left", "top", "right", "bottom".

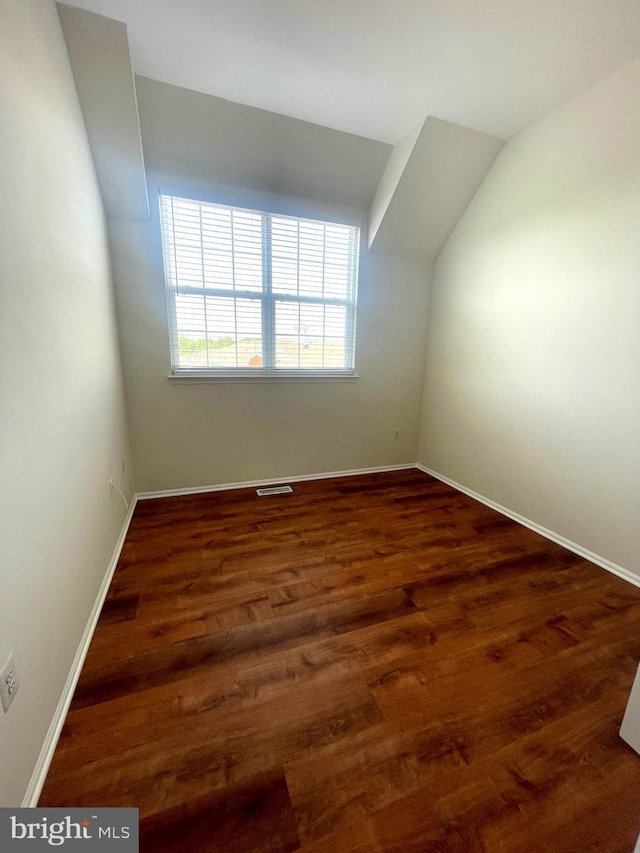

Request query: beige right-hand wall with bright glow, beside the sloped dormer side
[{"left": 419, "top": 60, "right": 640, "bottom": 574}]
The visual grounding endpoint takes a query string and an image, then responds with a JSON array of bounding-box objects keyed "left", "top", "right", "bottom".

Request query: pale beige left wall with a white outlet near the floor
[{"left": 0, "top": 0, "right": 131, "bottom": 806}]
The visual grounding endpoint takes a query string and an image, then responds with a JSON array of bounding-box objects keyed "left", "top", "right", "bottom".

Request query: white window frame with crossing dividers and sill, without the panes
[{"left": 158, "top": 195, "right": 361, "bottom": 382}]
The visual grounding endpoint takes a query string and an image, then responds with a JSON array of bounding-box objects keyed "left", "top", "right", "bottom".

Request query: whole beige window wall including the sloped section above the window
[{"left": 110, "top": 80, "right": 429, "bottom": 490}]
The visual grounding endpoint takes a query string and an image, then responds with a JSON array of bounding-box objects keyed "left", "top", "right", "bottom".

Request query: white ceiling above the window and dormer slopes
[{"left": 61, "top": 0, "right": 640, "bottom": 143}]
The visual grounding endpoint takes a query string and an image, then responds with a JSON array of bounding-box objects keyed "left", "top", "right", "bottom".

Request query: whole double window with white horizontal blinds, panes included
[{"left": 160, "top": 195, "right": 360, "bottom": 376}]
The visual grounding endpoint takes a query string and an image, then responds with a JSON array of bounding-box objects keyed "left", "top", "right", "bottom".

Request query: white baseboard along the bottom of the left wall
[{"left": 22, "top": 495, "right": 137, "bottom": 808}]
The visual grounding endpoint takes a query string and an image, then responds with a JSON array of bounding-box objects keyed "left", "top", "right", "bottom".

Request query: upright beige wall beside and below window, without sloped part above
[{"left": 110, "top": 194, "right": 428, "bottom": 491}]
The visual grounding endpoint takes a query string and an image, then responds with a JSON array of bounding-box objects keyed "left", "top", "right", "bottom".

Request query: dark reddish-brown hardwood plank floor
[{"left": 40, "top": 470, "right": 640, "bottom": 853}]
